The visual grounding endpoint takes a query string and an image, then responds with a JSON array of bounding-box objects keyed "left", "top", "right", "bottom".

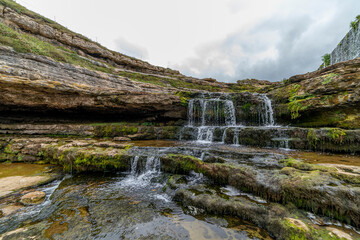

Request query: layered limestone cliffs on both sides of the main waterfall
[{"left": 0, "top": 0, "right": 360, "bottom": 128}]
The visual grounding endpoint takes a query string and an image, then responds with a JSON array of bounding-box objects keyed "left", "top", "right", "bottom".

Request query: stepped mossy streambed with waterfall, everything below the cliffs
[{"left": 0, "top": 94, "right": 360, "bottom": 239}]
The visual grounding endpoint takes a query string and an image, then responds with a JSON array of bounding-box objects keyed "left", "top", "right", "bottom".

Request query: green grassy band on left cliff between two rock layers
[{"left": 0, "top": 22, "right": 111, "bottom": 72}]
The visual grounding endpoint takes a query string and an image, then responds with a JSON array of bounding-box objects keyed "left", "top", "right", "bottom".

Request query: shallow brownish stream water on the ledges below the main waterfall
[{"left": 0, "top": 140, "right": 360, "bottom": 240}]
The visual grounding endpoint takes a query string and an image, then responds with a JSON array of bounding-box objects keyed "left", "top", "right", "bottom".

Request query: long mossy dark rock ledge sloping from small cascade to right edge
[{"left": 161, "top": 155, "right": 360, "bottom": 227}]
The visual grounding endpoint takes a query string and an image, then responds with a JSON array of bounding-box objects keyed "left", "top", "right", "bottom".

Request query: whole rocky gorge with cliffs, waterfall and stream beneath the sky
[{"left": 0, "top": 0, "right": 360, "bottom": 240}]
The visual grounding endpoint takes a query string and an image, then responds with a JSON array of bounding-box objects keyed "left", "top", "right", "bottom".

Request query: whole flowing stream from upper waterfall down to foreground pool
[{"left": 0, "top": 94, "right": 358, "bottom": 240}]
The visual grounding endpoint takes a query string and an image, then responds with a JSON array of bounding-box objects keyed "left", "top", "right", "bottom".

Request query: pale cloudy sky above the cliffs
[{"left": 17, "top": 0, "right": 360, "bottom": 82}]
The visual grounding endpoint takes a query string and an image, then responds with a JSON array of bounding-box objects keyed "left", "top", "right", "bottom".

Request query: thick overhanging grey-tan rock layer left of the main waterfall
[{"left": 0, "top": 47, "right": 186, "bottom": 123}]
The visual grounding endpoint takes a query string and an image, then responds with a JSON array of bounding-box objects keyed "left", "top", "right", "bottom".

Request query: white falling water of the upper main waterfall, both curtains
[{"left": 180, "top": 93, "right": 275, "bottom": 145}]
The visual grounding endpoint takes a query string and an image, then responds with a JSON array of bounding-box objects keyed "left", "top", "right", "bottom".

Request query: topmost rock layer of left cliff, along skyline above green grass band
[{"left": 0, "top": 1, "right": 180, "bottom": 75}]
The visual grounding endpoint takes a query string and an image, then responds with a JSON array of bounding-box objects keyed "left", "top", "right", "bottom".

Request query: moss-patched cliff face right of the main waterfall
[{"left": 268, "top": 59, "right": 360, "bottom": 128}]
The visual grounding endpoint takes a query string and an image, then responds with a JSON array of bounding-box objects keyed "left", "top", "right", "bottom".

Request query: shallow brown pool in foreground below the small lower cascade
[{"left": 0, "top": 174, "right": 271, "bottom": 239}]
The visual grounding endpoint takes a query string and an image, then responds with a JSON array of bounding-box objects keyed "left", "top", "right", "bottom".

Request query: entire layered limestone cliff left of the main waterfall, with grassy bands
[{"left": 0, "top": 0, "right": 227, "bottom": 122}]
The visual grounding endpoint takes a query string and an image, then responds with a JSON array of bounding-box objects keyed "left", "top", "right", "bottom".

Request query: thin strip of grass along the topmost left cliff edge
[{"left": 0, "top": 0, "right": 91, "bottom": 41}]
